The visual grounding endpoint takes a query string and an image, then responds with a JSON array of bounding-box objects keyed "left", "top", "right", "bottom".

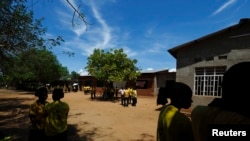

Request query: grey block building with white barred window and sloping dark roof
[{"left": 168, "top": 19, "right": 250, "bottom": 106}]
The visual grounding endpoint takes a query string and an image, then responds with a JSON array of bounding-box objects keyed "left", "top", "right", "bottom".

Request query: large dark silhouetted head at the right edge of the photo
[{"left": 222, "top": 62, "right": 250, "bottom": 104}]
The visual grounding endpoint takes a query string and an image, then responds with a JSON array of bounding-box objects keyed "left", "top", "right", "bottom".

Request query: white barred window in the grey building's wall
[{"left": 194, "top": 66, "right": 226, "bottom": 97}]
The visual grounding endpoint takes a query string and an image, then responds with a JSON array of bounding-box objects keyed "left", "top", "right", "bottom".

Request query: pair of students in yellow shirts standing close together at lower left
[{"left": 28, "top": 87, "right": 69, "bottom": 141}]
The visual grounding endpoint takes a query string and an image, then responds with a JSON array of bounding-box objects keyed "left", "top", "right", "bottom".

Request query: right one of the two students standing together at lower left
[{"left": 45, "top": 88, "right": 69, "bottom": 141}]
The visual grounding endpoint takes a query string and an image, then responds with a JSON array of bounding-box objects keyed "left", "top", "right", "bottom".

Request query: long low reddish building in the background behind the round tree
[{"left": 78, "top": 69, "right": 176, "bottom": 96}]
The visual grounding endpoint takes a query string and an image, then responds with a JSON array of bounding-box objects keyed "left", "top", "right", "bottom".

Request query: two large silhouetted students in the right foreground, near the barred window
[{"left": 157, "top": 62, "right": 250, "bottom": 141}]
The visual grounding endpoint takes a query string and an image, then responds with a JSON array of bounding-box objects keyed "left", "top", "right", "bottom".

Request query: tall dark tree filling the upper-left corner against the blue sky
[{"left": 0, "top": 0, "right": 64, "bottom": 71}]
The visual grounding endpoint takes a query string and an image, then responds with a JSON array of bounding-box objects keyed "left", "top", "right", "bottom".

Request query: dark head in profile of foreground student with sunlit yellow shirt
[{"left": 169, "top": 82, "right": 193, "bottom": 109}]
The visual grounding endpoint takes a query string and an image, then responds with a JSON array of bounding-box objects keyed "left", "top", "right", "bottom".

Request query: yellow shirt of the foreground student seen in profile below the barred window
[{"left": 157, "top": 105, "right": 194, "bottom": 141}]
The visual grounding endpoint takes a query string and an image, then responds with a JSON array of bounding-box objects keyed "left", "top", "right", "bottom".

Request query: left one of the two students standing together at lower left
[{"left": 29, "top": 87, "right": 49, "bottom": 141}]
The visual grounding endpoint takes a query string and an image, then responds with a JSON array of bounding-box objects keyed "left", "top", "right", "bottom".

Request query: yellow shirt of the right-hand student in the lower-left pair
[{"left": 45, "top": 101, "right": 69, "bottom": 136}]
